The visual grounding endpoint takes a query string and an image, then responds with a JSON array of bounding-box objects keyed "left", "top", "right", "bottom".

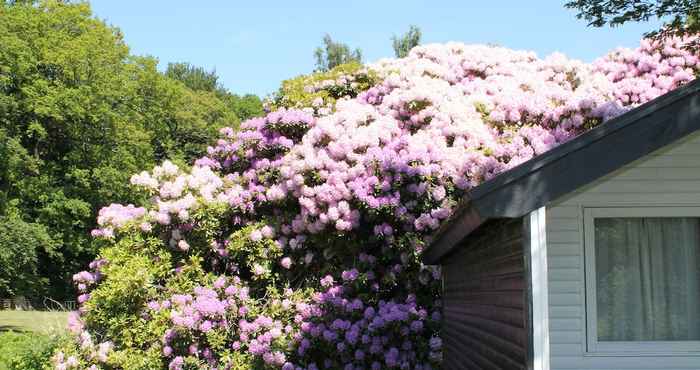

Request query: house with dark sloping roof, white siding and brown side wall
[{"left": 424, "top": 81, "right": 700, "bottom": 370}]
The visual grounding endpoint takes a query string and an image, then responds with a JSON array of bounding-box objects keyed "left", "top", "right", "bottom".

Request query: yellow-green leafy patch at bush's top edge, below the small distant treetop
[{"left": 271, "top": 62, "right": 379, "bottom": 112}]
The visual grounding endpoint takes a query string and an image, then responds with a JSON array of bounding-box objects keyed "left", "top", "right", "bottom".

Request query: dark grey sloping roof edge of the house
[{"left": 423, "top": 79, "right": 700, "bottom": 264}]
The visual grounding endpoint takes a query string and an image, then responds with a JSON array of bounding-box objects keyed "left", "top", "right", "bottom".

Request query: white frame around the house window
[{"left": 583, "top": 205, "right": 700, "bottom": 356}]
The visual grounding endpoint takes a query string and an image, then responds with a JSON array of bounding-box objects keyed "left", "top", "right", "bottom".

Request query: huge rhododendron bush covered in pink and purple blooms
[{"left": 54, "top": 39, "right": 700, "bottom": 370}]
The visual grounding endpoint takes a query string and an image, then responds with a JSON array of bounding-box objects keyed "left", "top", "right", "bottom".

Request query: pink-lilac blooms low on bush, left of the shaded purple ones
[{"left": 147, "top": 276, "right": 302, "bottom": 370}]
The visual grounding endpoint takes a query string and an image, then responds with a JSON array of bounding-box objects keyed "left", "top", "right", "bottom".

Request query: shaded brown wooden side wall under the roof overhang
[{"left": 442, "top": 219, "right": 527, "bottom": 369}]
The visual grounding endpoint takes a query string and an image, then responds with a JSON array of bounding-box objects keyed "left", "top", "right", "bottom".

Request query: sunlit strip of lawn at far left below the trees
[{"left": 0, "top": 310, "right": 68, "bottom": 333}]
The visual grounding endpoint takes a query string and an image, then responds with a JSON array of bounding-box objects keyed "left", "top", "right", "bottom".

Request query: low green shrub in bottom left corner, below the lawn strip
[{"left": 0, "top": 331, "right": 61, "bottom": 370}]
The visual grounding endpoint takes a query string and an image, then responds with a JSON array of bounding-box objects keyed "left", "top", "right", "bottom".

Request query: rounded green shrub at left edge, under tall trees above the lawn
[{"left": 0, "top": 217, "right": 55, "bottom": 297}]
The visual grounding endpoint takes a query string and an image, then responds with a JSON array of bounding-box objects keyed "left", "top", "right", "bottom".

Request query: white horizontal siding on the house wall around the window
[{"left": 546, "top": 134, "right": 700, "bottom": 370}]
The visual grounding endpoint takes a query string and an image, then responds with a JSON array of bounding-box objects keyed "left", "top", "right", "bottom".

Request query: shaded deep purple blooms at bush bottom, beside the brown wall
[{"left": 290, "top": 286, "right": 442, "bottom": 370}]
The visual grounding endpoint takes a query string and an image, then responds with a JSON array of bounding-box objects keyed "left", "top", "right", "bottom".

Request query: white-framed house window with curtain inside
[{"left": 584, "top": 207, "right": 700, "bottom": 354}]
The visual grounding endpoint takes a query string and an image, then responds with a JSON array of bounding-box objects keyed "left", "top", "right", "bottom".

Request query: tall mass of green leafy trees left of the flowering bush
[{"left": 0, "top": 0, "right": 243, "bottom": 298}]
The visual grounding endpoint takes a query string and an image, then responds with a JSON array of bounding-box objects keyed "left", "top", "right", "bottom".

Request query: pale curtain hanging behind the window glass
[{"left": 594, "top": 217, "right": 700, "bottom": 341}]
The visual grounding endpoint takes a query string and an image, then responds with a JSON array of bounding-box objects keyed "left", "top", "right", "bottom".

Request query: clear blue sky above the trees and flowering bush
[{"left": 91, "top": 0, "right": 655, "bottom": 96}]
